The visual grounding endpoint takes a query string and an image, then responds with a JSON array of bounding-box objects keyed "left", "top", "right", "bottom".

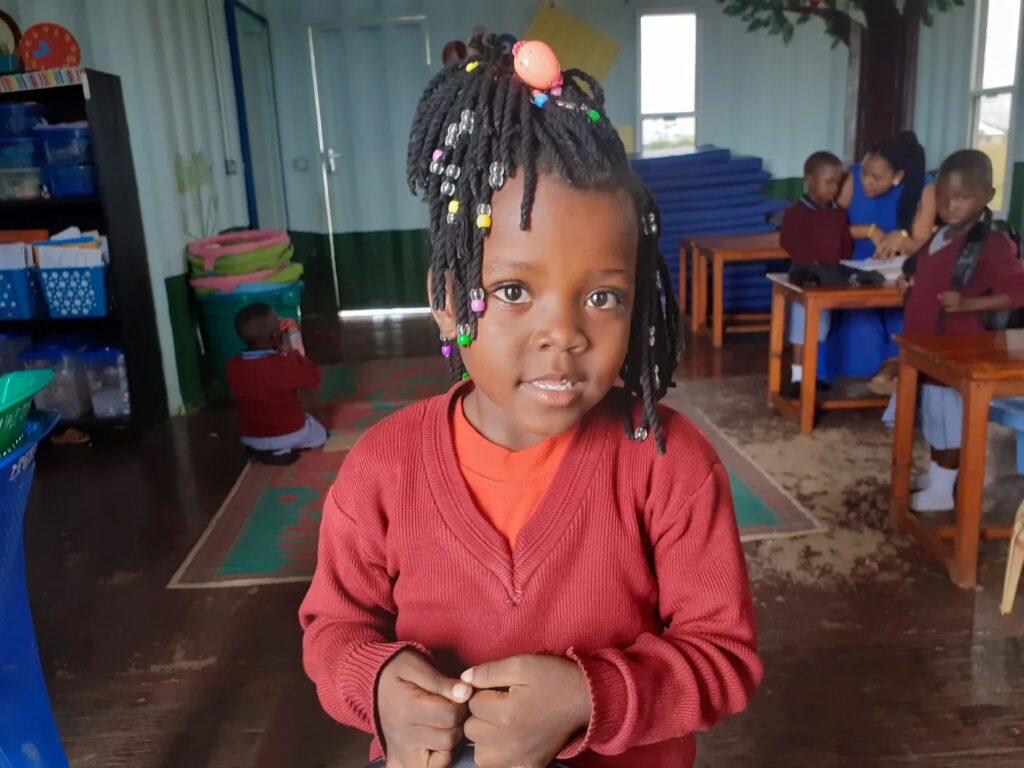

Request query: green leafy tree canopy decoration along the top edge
[{"left": 717, "top": 0, "right": 965, "bottom": 48}]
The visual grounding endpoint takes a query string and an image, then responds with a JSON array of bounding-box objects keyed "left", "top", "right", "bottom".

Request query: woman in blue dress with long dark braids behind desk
[{"left": 819, "top": 131, "right": 935, "bottom": 388}]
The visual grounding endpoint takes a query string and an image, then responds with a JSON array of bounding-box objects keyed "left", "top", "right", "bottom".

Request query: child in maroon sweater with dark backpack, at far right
[{"left": 899, "top": 150, "right": 1024, "bottom": 512}]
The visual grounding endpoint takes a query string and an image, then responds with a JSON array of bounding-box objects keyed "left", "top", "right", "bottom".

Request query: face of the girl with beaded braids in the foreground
[{"left": 435, "top": 174, "right": 639, "bottom": 451}]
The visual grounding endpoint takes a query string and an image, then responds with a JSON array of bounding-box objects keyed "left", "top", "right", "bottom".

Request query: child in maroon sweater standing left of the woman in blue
[{"left": 779, "top": 152, "right": 853, "bottom": 397}]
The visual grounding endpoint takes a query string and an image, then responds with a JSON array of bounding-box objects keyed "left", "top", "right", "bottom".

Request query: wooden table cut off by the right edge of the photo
[{"left": 891, "top": 331, "right": 1024, "bottom": 587}]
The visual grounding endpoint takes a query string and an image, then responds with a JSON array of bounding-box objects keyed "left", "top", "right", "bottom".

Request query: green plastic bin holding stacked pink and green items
[{"left": 196, "top": 283, "right": 302, "bottom": 382}]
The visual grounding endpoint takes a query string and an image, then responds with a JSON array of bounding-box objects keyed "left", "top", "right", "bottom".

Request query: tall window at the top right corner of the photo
[{"left": 971, "top": 0, "right": 1021, "bottom": 212}]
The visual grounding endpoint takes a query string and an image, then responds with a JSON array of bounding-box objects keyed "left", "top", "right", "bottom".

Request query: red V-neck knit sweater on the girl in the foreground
[{"left": 299, "top": 388, "right": 762, "bottom": 768}]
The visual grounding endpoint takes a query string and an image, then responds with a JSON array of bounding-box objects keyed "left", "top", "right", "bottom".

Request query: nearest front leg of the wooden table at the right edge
[{"left": 950, "top": 382, "right": 992, "bottom": 588}]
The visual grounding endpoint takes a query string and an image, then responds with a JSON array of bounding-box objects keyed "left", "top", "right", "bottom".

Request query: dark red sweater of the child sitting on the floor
[{"left": 227, "top": 352, "right": 321, "bottom": 437}]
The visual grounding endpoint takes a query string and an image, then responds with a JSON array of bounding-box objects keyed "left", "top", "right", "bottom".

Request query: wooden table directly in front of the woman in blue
[{"left": 768, "top": 274, "right": 903, "bottom": 434}]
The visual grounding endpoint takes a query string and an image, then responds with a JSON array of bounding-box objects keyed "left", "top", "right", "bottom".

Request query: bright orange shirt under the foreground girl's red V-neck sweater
[{"left": 452, "top": 397, "right": 575, "bottom": 552}]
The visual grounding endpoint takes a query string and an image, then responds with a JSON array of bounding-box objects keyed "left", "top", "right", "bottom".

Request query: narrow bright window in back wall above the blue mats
[{"left": 640, "top": 13, "right": 697, "bottom": 152}]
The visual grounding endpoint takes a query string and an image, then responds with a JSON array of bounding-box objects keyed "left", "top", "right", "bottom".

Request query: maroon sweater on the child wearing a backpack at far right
[{"left": 903, "top": 231, "right": 1024, "bottom": 336}]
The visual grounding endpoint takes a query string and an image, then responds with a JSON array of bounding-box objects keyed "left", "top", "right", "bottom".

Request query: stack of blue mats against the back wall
[{"left": 633, "top": 147, "right": 788, "bottom": 312}]
